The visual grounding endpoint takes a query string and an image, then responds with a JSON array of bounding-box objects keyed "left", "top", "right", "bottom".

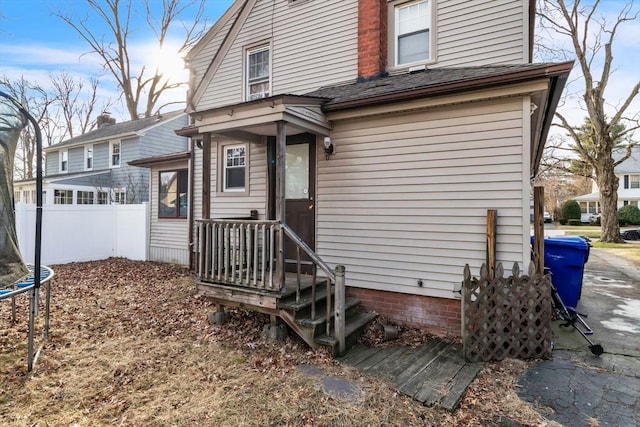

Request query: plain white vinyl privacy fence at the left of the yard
[{"left": 16, "top": 203, "right": 149, "bottom": 265}]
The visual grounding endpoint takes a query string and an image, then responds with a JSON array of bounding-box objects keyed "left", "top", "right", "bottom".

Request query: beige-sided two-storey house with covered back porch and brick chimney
[{"left": 141, "top": 0, "right": 572, "bottom": 345}]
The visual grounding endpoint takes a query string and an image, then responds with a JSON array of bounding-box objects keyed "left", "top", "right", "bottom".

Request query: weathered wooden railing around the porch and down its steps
[{"left": 196, "top": 219, "right": 345, "bottom": 351}]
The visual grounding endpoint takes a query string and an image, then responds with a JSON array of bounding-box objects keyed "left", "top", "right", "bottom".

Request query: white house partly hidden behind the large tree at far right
[{"left": 575, "top": 147, "right": 640, "bottom": 219}]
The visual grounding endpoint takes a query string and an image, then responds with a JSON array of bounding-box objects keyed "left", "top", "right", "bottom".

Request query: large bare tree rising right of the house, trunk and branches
[{"left": 538, "top": 0, "right": 640, "bottom": 242}]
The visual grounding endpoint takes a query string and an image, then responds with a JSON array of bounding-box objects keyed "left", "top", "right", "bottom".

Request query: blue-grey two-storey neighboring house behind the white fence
[{"left": 37, "top": 111, "right": 188, "bottom": 204}]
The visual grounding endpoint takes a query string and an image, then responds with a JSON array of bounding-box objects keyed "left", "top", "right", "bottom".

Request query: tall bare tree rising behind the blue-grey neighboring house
[{"left": 57, "top": 0, "right": 206, "bottom": 120}]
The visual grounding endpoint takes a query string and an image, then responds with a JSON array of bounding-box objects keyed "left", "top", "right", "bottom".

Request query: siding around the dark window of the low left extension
[{"left": 149, "top": 162, "right": 191, "bottom": 265}]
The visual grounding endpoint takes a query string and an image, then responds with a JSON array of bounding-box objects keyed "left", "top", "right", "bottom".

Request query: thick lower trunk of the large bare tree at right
[{"left": 597, "top": 160, "right": 623, "bottom": 243}]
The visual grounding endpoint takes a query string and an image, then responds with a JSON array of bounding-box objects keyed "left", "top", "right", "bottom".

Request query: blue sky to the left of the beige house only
[{"left": 0, "top": 0, "right": 233, "bottom": 120}]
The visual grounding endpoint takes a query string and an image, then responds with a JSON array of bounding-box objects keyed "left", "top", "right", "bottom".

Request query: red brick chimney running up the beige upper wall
[{"left": 358, "top": 0, "right": 387, "bottom": 81}]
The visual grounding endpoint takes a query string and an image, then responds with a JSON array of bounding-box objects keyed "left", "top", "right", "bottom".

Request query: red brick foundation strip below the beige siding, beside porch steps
[{"left": 347, "top": 287, "right": 462, "bottom": 337}]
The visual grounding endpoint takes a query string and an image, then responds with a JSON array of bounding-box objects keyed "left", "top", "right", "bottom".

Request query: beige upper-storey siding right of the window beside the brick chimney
[{"left": 433, "top": 0, "right": 528, "bottom": 68}]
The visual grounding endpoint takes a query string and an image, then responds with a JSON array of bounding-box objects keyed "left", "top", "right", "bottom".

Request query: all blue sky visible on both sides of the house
[{"left": 0, "top": 0, "right": 640, "bottom": 136}]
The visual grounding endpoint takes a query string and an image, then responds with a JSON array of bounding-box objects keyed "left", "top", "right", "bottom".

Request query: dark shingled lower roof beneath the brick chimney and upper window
[{"left": 306, "top": 63, "right": 559, "bottom": 110}]
